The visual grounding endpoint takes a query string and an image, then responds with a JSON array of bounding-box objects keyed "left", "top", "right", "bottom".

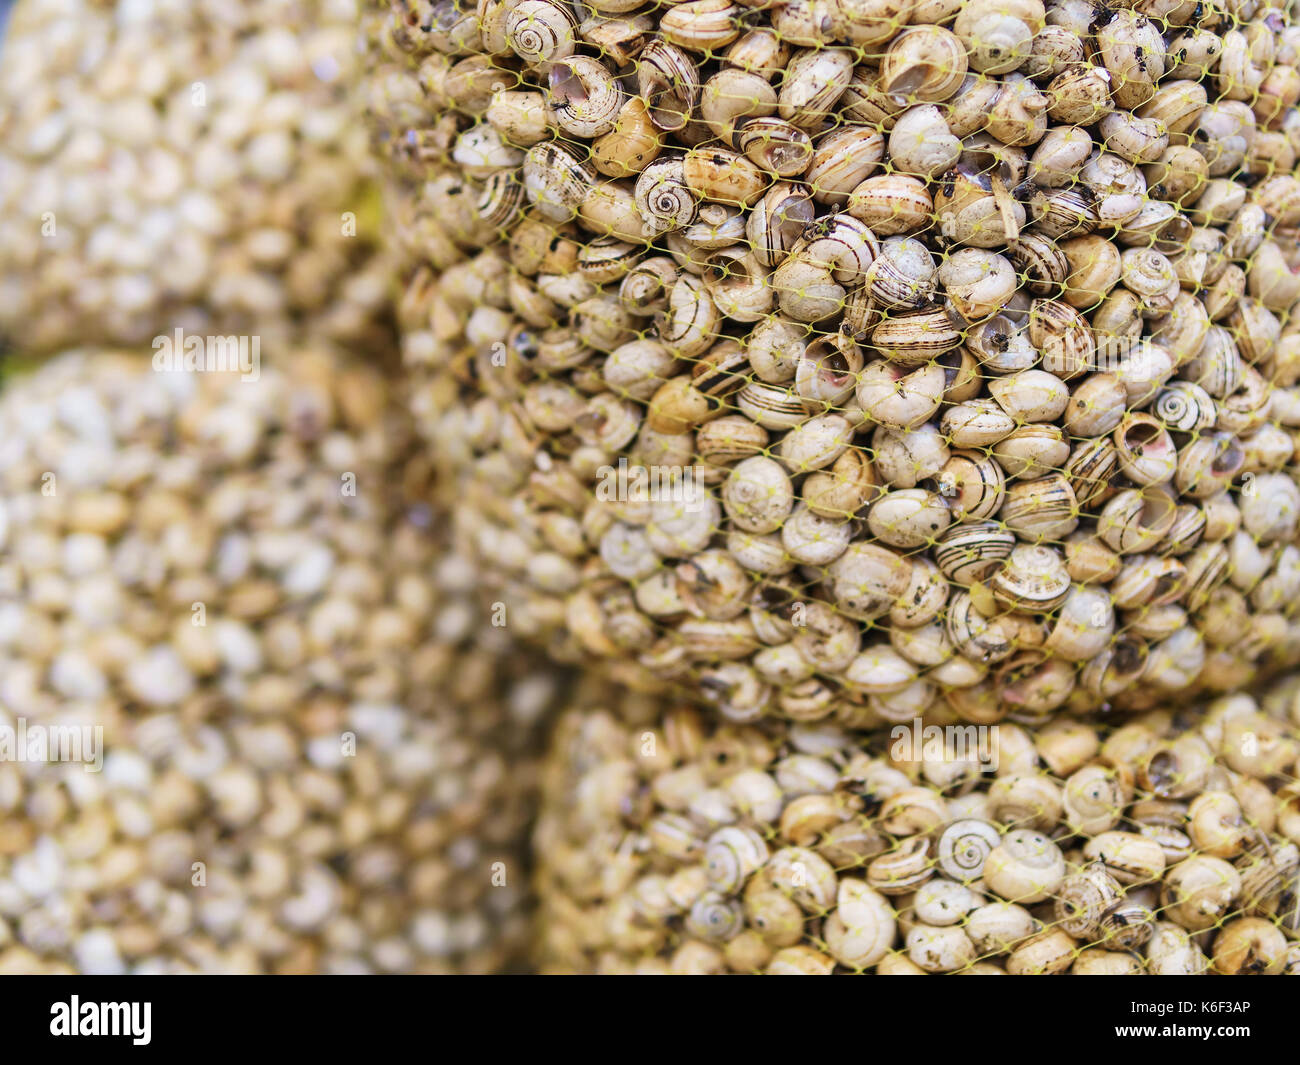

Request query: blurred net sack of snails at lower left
[{"left": 0, "top": 347, "right": 564, "bottom": 973}]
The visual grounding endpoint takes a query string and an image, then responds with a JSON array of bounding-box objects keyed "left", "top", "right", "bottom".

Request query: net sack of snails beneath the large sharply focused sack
[{"left": 534, "top": 676, "right": 1300, "bottom": 975}]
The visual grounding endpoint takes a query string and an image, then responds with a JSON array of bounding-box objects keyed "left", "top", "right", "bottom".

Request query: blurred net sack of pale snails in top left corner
[{"left": 0, "top": 0, "right": 394, "bottom": 355}]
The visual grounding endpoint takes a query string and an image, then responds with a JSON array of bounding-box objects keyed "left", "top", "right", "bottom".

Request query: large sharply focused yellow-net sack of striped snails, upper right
[{"left": 369, "top": 0, "right": 1300, "bottom": 726}]
